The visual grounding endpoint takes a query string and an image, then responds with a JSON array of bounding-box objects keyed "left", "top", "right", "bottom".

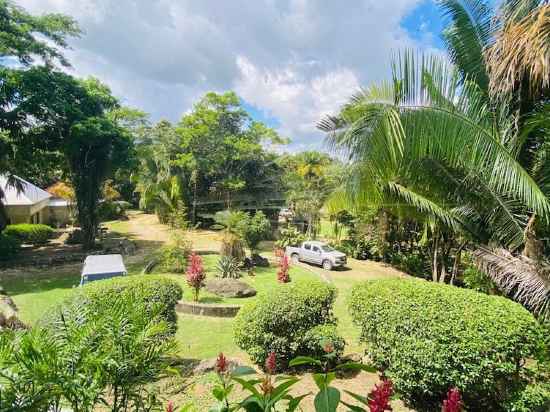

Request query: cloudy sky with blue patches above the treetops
[{"left": 16, "top": 0, "right": 450, "bottom": 151}]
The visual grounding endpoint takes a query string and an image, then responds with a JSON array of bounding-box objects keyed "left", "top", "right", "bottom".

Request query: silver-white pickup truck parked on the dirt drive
[{"left": 285, "top": 241, "right": 347, "bottom": 270}]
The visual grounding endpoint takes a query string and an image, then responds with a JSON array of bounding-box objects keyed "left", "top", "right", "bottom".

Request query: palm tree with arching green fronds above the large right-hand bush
[{"left": 319, "top": 50, "right": 550, "bottom": 318}]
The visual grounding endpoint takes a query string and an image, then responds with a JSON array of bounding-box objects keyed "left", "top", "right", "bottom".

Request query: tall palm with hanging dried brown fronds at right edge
[{"left": 440, "top": 0, "right": 550, "bottom": 316}]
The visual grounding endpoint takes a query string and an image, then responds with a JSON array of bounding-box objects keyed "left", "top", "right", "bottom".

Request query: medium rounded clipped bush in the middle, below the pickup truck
[{"left": 233, "top": 281, "right": 343, "bottom": 367}]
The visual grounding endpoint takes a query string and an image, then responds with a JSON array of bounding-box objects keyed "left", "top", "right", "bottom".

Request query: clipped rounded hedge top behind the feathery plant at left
[{"left": 51, "top": 275, "right": 182, "bottom": 332}]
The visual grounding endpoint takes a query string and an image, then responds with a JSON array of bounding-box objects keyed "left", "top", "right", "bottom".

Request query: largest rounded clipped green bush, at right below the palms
[{"left": 349, "top": 279, "right": 542, "bottom": 411}]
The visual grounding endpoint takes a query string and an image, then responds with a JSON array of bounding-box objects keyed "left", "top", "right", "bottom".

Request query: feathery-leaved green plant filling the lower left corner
[{"left": 0, "top": 292, "right": 176, "bottom": 411}]
